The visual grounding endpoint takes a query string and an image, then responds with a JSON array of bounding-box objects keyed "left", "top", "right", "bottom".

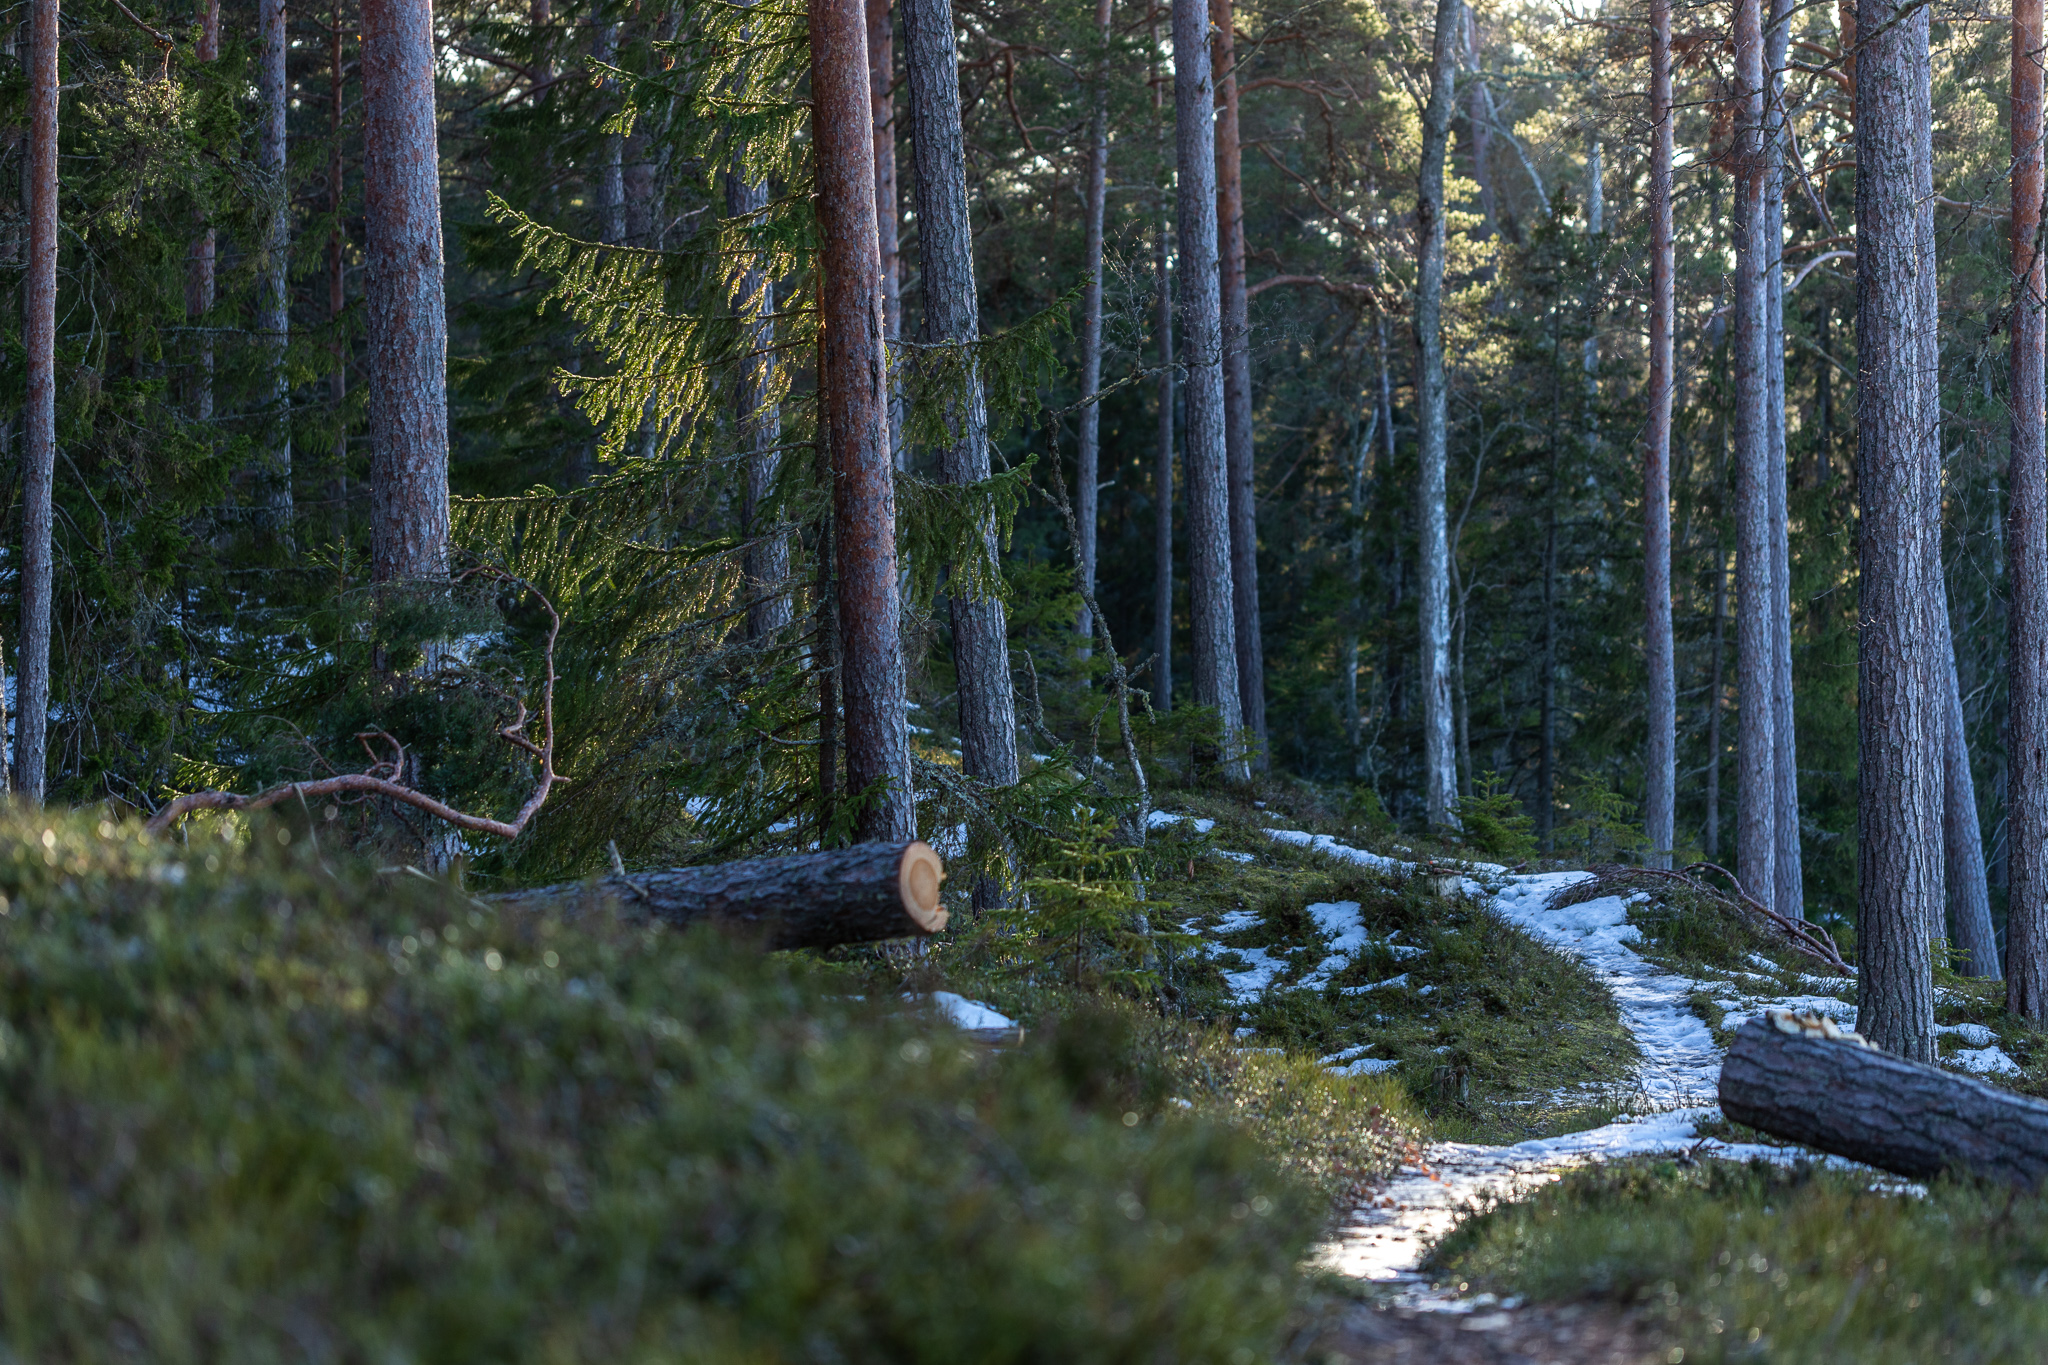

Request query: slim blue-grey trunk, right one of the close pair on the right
[{"left": 1763, "top": 0, "right": 1806, "bottom": 919}]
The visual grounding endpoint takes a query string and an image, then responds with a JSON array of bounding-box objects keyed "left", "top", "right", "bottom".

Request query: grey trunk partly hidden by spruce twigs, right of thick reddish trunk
[{"left": 901, "top": 0, "right": 1018, "bottom": 802}]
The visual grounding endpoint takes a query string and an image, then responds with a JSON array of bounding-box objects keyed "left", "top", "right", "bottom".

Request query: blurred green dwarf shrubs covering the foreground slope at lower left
[{"left": 0, "top": 817, "right": 1325, "bottom": 1365}]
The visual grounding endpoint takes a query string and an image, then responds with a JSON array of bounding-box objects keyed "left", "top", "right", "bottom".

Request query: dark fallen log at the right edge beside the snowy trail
[{"left": 1720, "top": 1011, "right": 2048, "bottom": 1187}]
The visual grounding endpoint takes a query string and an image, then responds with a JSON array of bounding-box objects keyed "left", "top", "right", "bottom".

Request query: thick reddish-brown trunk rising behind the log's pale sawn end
[{"left": 809, "top": 0, "right": 915, "bottom": 841}]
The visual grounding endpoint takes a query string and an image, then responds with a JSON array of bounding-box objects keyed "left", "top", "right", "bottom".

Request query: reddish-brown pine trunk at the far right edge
[{"left": 2005, "top": 0, "right": 2048, "bottom": 1023}]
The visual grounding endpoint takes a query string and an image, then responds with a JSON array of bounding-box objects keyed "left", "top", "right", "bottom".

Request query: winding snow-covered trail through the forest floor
[{"left": 1274, "top": 855, "right": 1855, "bottom": 1308}]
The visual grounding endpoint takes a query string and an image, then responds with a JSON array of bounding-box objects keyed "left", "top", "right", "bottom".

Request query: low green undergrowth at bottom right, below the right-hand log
[{"left": 1434, "top": 1160, "right": 2048, "bottom": 1365}]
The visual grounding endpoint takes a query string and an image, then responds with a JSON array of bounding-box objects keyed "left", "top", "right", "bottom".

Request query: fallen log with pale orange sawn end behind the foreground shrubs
[{"left": 498, "top": 839, "right": 946, "bottom": 948}]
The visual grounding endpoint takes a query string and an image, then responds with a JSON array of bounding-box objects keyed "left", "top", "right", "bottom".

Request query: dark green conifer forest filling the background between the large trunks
[{"left": 0, "top": 0, "right": 2009, "bottom": 941}]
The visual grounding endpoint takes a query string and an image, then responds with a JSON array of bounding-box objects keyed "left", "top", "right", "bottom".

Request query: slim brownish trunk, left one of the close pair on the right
[{"left": 1729, "top": 0, "right": 1778, "bottom": 905}]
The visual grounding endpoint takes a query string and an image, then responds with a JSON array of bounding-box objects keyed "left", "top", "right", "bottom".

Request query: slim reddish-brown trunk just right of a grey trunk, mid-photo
[{"left": 1208, "top": 0, "right": 1266, "bottom": 769}]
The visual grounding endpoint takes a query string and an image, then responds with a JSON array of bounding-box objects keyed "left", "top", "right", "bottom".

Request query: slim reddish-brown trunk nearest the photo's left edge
[{"left": 14, "top": 0, "right": 57, "bottom": 804}]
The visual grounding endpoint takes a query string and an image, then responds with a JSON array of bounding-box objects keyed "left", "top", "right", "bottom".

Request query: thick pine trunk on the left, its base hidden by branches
[{"left": 360, "top": 0, "right": 449, "bottom": 583}]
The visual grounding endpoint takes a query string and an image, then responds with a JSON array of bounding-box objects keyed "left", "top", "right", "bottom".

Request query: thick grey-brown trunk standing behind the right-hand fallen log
[{"left": 1855, "top": 0, "right": 1942, "bottom": 1062}]
